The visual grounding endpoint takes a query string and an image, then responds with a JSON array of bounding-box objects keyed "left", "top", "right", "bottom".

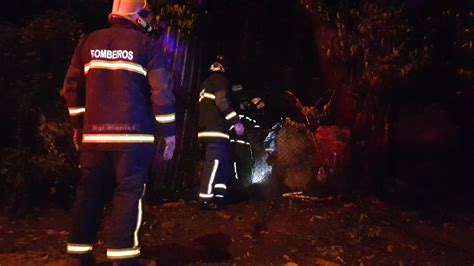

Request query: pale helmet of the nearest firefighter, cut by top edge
[{"left": 109, "top": 0, "right": 153, "bottom": 32}]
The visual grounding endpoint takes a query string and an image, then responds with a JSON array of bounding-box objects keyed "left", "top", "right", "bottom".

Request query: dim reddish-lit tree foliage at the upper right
[{"left": 312, "top": 1, "right": 432, "bottom": 127}]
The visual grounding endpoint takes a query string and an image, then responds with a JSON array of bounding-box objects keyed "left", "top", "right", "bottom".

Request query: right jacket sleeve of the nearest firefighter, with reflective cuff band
[{"left": 148, "top": 41, "right": 176, "bottom": 137}]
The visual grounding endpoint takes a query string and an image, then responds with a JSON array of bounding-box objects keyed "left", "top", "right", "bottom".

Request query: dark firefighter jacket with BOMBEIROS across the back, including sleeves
[{"left": 62, "top": 19, "right": 175, "bottom": 149}]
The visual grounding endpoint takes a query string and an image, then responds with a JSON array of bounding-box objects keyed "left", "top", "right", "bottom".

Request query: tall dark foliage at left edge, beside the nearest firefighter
[{"left": 0, "top": 11, "right": 82, "bottom": 214}]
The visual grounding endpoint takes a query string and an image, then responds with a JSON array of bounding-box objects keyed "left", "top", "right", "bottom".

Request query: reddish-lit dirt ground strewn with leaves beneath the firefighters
[{"left": 0, "top": 195, "right": 474, "bottom": 266}]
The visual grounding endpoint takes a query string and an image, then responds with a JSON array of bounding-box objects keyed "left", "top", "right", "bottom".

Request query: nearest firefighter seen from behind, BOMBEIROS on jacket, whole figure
[{"left": 62, "top": 0, "right": 175, "bottom": 265}]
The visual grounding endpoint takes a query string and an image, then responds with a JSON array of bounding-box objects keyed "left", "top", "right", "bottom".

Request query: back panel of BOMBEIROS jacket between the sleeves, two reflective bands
[{"left": 81, "top": 25, "right": 154, "bottom": 149}]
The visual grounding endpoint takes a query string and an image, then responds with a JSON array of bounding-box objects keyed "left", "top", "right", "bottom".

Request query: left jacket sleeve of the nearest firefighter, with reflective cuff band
[{"left": 61, "top": 36, "right": 86, "bottom": 129}]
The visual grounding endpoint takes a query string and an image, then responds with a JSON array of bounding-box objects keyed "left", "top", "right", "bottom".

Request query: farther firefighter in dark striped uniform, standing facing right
[{"left": 198, "top": 56, "right": 245, "bottom": 209}]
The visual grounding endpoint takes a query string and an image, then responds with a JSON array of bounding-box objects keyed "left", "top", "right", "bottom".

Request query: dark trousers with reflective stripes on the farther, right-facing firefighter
[{"left": 199, "top": 141, "right": 233, "bottom": 202}]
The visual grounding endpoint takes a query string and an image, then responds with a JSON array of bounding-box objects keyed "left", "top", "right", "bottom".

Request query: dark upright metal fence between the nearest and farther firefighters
[{"left": 151, "top": 25, "right": 202, "bottom": 196}]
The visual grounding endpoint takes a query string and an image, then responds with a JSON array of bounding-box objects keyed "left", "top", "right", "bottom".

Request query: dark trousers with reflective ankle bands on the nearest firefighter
[{"left": 67, "top": 148, "right": 153, "bottom": 262}]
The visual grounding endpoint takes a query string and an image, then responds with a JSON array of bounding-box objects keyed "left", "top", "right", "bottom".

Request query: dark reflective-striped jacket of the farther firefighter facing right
[{"left": 198, "top": 72, "right": 240, "bottom": 141}]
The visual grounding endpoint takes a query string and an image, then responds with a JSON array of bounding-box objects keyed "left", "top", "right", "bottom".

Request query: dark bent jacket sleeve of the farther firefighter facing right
[{"left": 212, "top": 75, "right": 240, "bottom": 125}]
